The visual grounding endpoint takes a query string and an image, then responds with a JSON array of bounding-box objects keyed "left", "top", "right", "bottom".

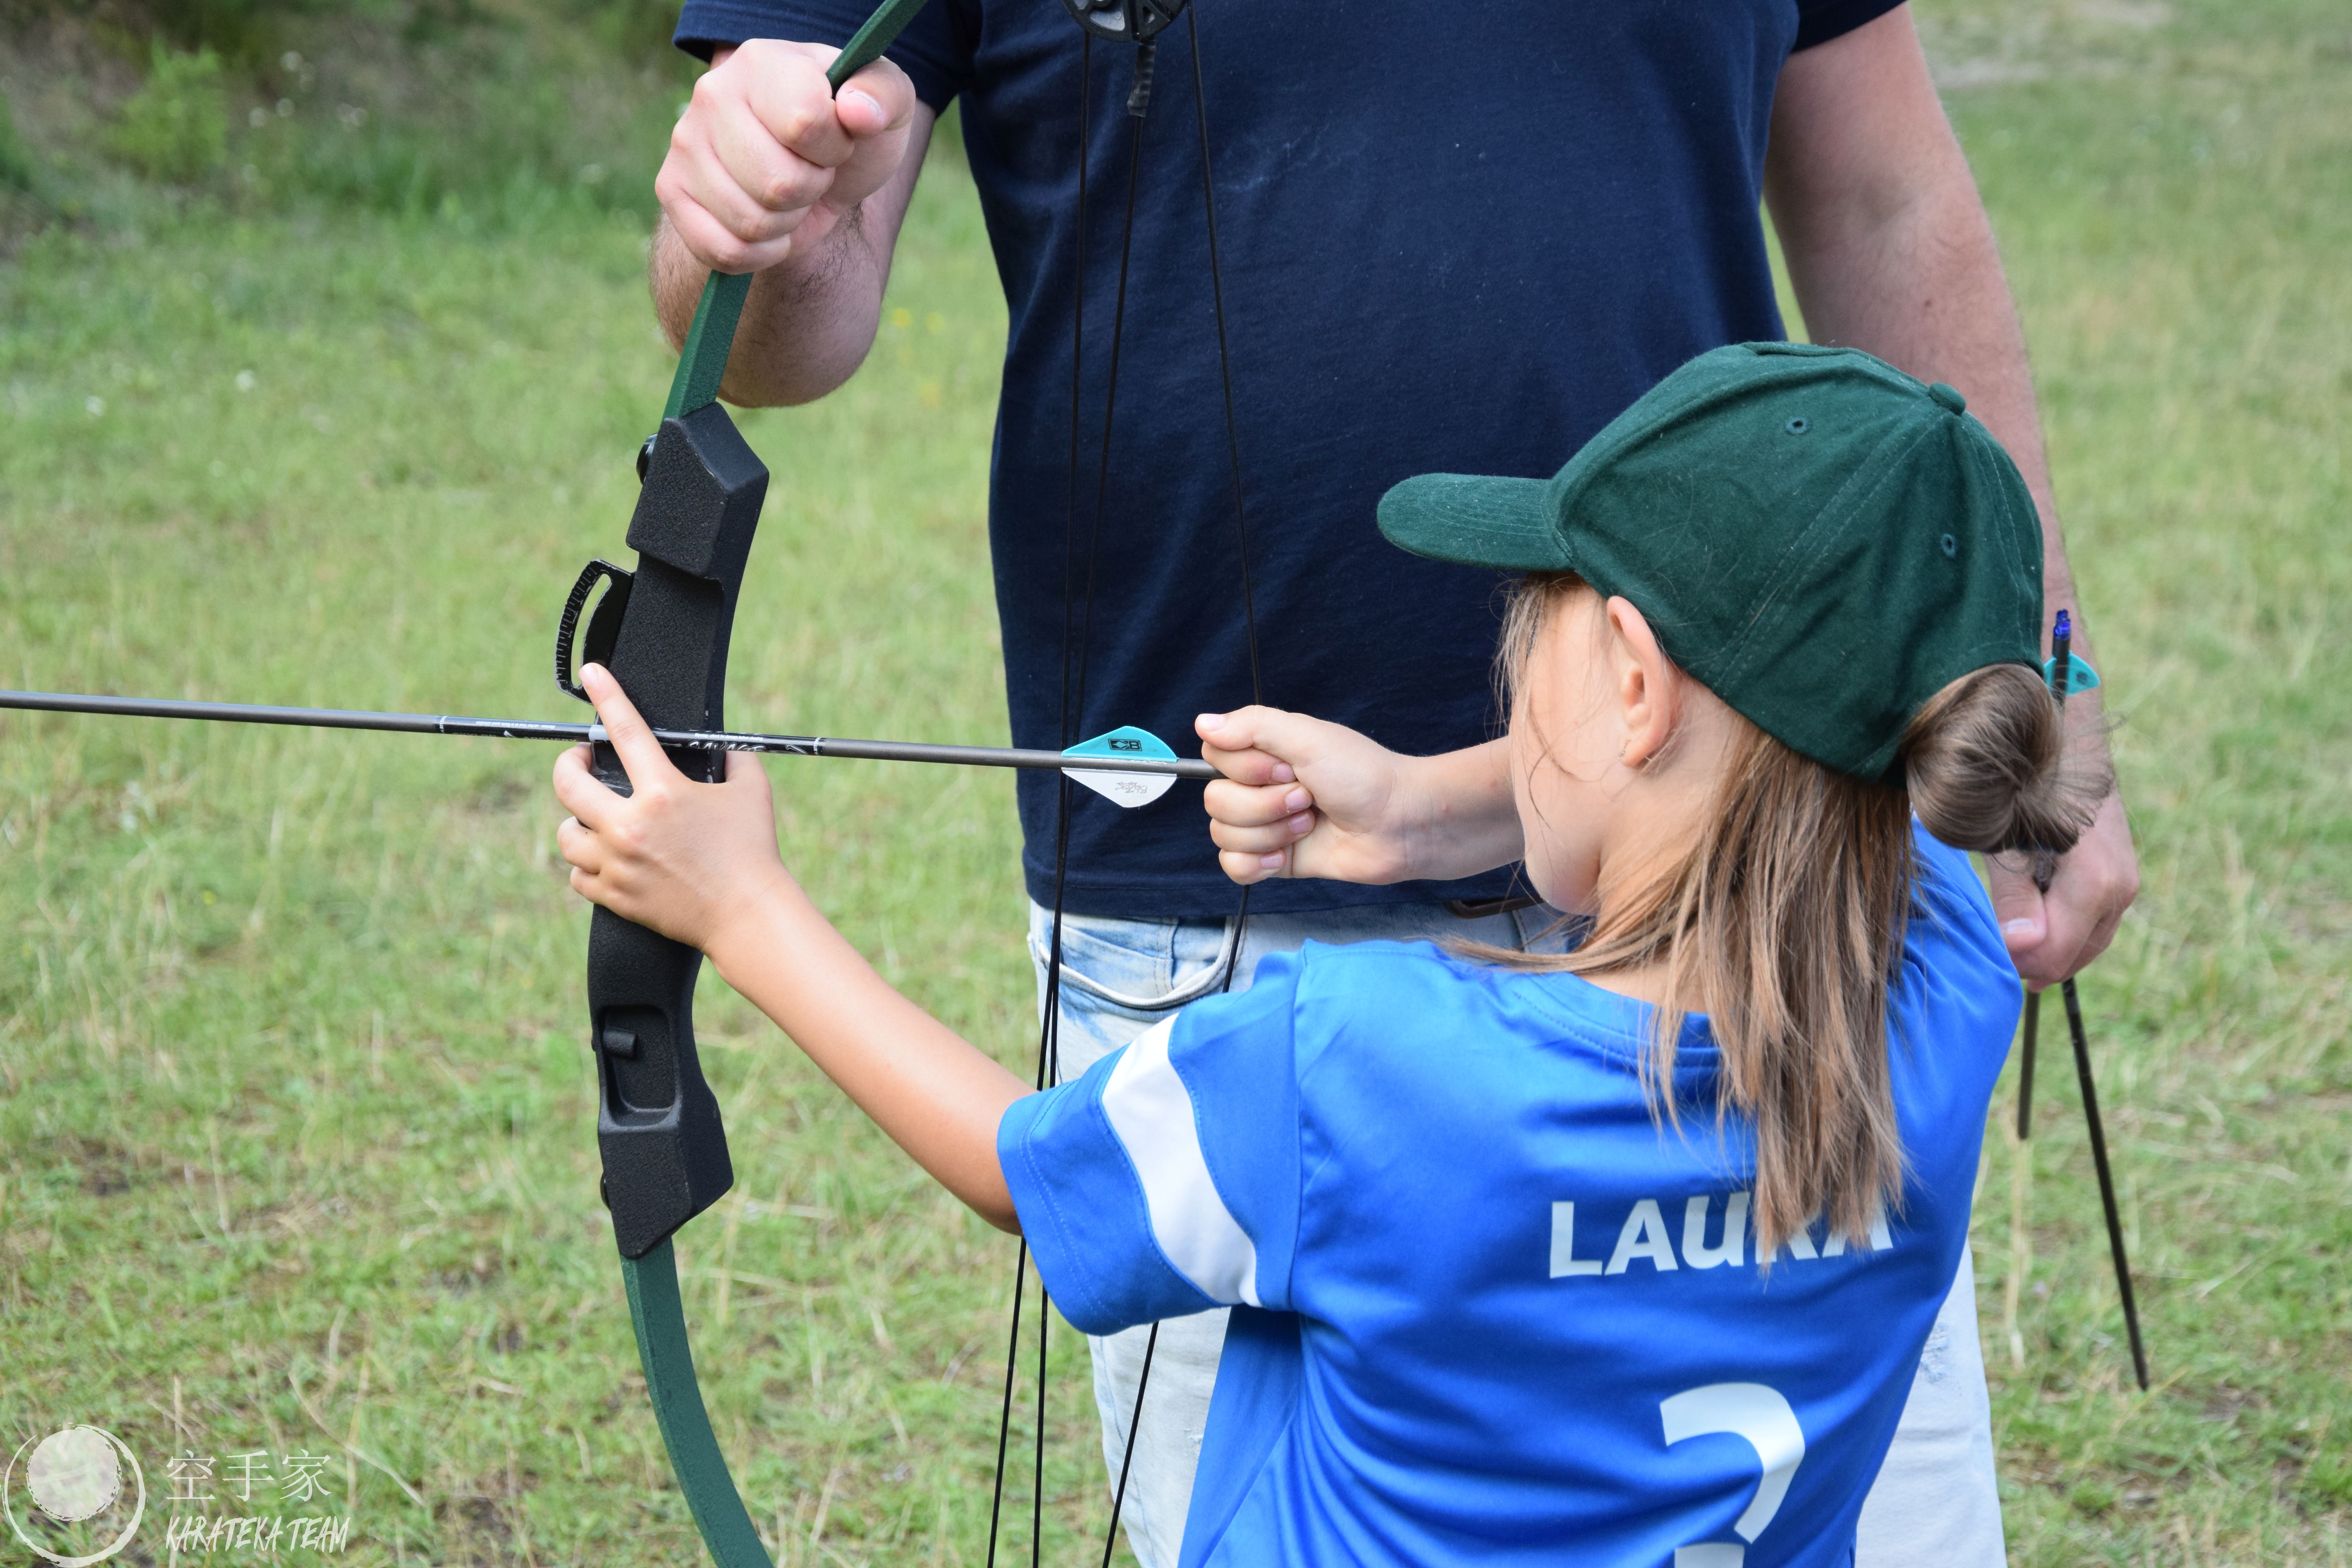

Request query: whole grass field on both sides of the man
[{"left": 0, "top": 0, "right": 2352, "bottom": 1568}]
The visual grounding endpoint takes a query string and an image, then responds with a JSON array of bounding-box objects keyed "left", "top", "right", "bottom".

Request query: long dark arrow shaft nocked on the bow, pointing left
[{"left": 0, "top": 691, "right": 1223, "bottom": 778}]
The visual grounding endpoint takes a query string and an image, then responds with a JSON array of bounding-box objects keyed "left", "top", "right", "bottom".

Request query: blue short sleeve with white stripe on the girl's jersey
[{"left": 997, "top": 955, "right": 1298, "bottom": 1333}]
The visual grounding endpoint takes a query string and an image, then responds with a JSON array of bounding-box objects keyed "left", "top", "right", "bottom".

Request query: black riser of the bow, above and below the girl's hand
[{"left": 574, "top": 404, "right": 767, "bottom": 1258}]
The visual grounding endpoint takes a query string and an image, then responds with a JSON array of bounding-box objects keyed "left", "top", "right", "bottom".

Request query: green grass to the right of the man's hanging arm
[{"left": 1919, "top": 7, "right": 2352, "bottom": 1563}]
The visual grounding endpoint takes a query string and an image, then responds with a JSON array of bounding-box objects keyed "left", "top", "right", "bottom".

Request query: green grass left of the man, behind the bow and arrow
[{"left": 0, "top": 147, "right": 1120, "bottom": 1563}]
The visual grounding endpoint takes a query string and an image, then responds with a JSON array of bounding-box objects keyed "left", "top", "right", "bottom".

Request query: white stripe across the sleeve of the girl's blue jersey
[{"left": 1103, "top": 1018, "right": 1258, "bottom": 1307}]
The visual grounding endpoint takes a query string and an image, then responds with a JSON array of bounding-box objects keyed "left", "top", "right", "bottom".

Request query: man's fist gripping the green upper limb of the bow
[{"left": 654, "top": 38, "right": 915, "bottom": 273}]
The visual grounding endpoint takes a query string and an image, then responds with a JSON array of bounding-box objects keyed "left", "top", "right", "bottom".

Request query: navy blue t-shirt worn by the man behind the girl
[{"left": 677, "top": 0, "right": 1893, "bottom": 917}]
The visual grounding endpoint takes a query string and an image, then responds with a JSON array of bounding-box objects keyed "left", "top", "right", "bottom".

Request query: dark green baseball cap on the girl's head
[{"left": 1381, "top": 343, "right": 2042, "bottom": 783}]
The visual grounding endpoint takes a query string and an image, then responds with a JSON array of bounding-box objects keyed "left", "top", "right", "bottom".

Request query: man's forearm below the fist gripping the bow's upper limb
[{"left": 647, "top": 96, "right": 931, "bottom": 407}]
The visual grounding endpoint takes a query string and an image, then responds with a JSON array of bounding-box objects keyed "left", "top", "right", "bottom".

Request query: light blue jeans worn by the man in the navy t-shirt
[{"left": 1030, "top": 903, "right": 2006, "bottom": 1568}]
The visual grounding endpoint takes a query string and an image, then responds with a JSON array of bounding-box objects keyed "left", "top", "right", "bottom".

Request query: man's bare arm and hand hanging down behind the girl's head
[{"left": 1764, "top": 7, "right": 2140, "bottom": 985}]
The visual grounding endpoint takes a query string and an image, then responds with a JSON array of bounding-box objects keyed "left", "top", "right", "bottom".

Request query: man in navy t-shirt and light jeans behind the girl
[{"left": 654, "top": 0, "right": 2136, "bottom": 1568}]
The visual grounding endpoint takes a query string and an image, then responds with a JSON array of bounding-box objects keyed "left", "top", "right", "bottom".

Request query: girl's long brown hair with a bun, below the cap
[{"left": 1477, "top": 573, "right": 2107, "bottom": 1260}]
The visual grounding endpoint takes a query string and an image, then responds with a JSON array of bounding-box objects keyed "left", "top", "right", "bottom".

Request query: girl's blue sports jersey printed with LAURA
[{"left": 997, "top": 835, "right": 2018, "bottom": 1568}]
